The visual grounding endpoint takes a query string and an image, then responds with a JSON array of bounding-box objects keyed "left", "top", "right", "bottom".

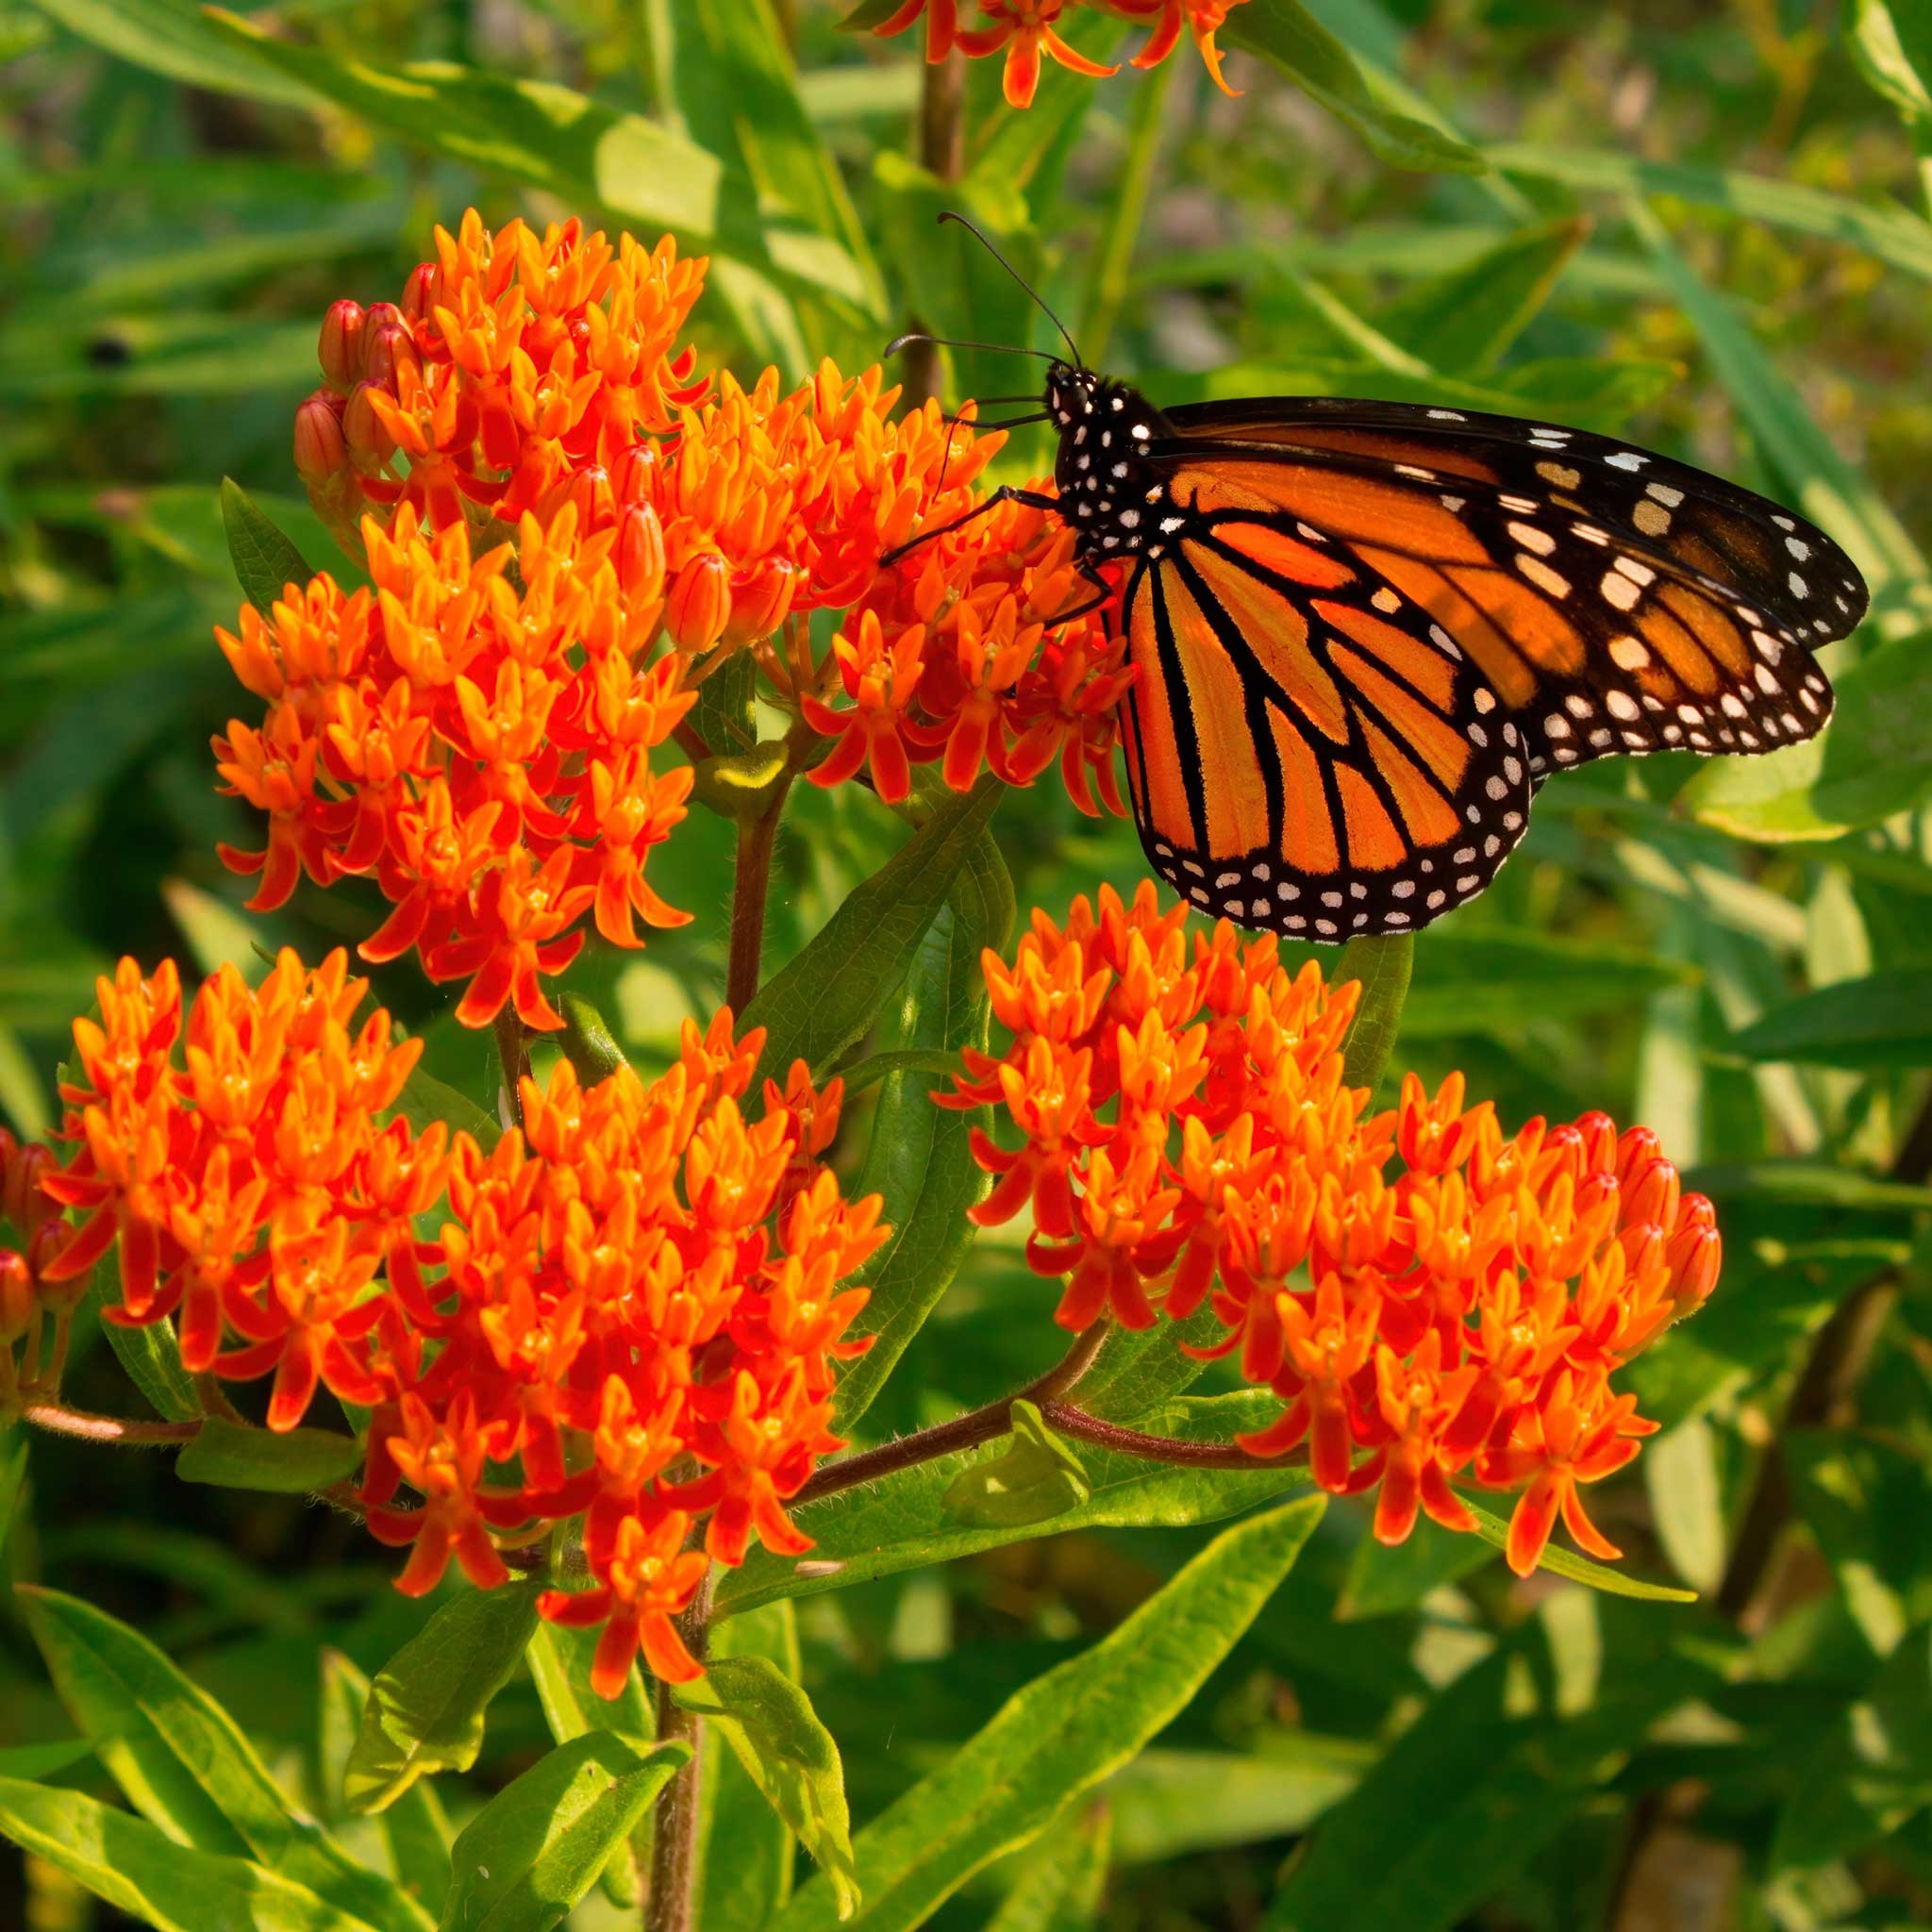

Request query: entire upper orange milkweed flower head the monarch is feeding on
[{"left": 227, "top": 210, "right": 1130, "bottom": 1028}]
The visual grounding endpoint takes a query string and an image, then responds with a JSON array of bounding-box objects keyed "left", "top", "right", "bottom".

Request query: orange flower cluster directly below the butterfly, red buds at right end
[{"left": 955, "top": 883, "right": 1722, "bottom": 1574}]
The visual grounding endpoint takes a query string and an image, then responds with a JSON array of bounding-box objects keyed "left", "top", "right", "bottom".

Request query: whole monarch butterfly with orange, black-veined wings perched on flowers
[{"left": 892, "top": 216, "right": 1866, "bottom": 942}]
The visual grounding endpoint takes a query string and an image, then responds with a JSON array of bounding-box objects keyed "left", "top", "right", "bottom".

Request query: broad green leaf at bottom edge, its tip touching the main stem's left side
[{"left": 441, "top": 1731, "right": 691, "bottom": 1932}]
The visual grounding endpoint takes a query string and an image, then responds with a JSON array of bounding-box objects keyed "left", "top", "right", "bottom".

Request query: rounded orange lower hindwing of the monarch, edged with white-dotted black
[{"left": 1123, "top": 512, "right": 1532, "bottom": 939}]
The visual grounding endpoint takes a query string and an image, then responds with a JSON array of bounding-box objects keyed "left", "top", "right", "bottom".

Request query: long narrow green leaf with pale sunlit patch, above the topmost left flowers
[{"left": 207, "top": 8, "right": 870, "bottom": 313}]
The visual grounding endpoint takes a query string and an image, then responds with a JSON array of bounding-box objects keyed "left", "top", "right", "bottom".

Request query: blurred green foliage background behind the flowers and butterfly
[{"left": 0, "top": 0, "right": 1932, "bottom": 1932}]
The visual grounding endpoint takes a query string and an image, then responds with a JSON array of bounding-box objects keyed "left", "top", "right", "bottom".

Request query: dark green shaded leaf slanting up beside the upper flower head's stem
[{"left": 740, "top": 774, "right": 1007, "bottom": 1080}]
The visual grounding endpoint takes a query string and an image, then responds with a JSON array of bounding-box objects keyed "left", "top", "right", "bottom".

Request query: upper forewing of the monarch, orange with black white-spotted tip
[{"left": 1163, "top": 398, "right": 1866, "bottom": 771}]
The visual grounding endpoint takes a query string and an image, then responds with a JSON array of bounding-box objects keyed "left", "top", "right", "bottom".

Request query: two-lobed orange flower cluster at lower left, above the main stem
[{"left": 37, "top": 951, "right": 887, "bottom": 1696}]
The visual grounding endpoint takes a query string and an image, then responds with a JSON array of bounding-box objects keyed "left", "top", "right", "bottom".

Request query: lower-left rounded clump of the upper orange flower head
[{"left": 214, "top": 502, "right": 695, "bottom": 1028}]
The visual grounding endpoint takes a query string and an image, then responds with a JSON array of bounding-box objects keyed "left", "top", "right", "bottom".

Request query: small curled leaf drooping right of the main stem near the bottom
[{"left": 675, "top": 1657, "right": 859, "bottom": 1919}]
